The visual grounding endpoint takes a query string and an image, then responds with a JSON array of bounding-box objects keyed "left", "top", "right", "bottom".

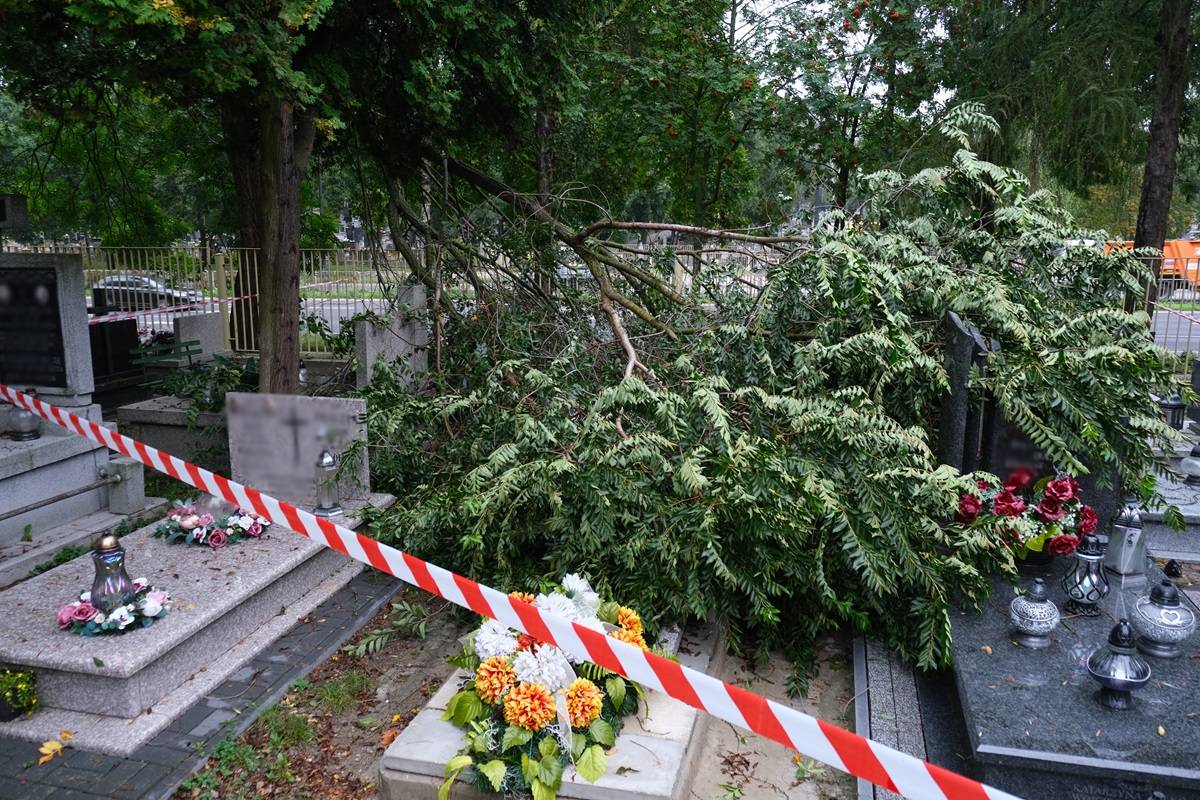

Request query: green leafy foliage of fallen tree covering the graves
[{"left": 365, "top": 118, "right": 1175, "bottom": 691}]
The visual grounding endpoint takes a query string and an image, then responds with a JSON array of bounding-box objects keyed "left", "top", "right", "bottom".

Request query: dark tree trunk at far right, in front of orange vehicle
[{"left": 1133, "top": 0, "right": 1192, "bottom": 297}]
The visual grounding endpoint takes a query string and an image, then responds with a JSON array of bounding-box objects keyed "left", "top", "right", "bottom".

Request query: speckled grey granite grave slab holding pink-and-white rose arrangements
[{"left": 0, "top": 495, "right": 392, "bottom": 754}]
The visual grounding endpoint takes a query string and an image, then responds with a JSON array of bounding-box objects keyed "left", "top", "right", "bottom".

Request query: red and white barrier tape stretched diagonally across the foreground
[{"left": 0, "top": 384, "right": 1018, "bottom": 800}]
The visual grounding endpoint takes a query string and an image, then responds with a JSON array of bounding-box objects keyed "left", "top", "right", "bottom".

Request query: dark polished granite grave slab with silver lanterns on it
[{"left": 952, "top": 558, "right": 1200, "bottom": 800}]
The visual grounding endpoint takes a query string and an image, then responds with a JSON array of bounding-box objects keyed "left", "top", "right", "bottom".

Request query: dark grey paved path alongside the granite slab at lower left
[{"left": 0, "top": 571, "right": 402, "bottom": 800}]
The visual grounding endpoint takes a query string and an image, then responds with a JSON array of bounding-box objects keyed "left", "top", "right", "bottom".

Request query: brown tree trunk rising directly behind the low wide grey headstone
[{"left": 258, "top": 92, "right": 316, "bottom": 393}]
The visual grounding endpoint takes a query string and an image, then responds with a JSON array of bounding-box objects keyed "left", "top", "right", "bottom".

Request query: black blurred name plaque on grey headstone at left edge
[{"left": 0, "top": 267, "right": 67, "bottom": 389}]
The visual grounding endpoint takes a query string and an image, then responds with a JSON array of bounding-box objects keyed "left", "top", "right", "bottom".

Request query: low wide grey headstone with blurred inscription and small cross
[{"left": 226, "top": 392, "right": 370, "bottom": 506}]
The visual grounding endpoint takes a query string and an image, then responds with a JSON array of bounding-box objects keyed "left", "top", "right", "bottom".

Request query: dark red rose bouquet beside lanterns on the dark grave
[{"left": 956, "top": 467, "right": 1100, "bottom": 558}]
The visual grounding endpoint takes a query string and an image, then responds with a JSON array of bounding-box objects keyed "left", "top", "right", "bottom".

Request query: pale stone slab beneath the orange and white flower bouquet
[{"left": 379, "top": 625, "right": 718, "bottom": 800}]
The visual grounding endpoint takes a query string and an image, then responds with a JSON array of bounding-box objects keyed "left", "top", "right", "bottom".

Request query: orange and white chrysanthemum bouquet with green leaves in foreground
[{"left": 438, "top": 575, "right": 650, "bottom": 800}]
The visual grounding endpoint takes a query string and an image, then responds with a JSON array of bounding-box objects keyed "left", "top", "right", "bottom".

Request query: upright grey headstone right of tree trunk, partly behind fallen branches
[{"left": 354, "top": 285, "right": 430, "bottom": 386}]
